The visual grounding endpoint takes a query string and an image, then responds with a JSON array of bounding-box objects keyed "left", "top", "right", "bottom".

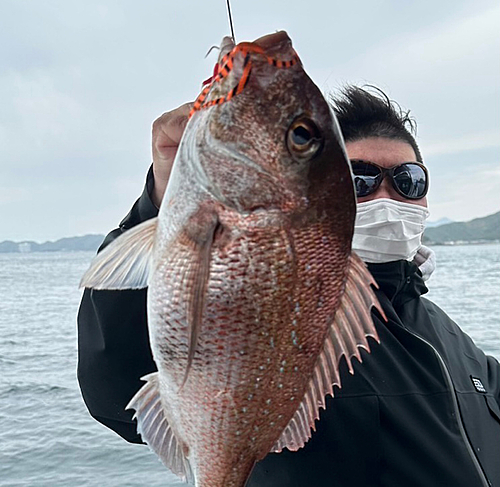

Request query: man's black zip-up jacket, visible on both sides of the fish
[{"left": 78, "top": 167, "right": 500, "bottom": 487}]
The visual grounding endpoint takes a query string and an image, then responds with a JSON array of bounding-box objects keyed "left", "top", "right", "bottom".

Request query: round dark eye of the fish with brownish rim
[{"left": 286, "top": 117, "right": 323, "bottom": 162}]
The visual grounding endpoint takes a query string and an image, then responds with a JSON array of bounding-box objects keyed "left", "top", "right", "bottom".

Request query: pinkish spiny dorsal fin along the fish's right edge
[{"left": 271, "top": 254, "right": 385, "bottom": 452}]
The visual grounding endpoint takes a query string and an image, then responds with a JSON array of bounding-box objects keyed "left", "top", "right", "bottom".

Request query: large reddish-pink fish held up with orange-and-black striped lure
[{"left": 82, "top": 31, "right": 383, "bottom": 487}]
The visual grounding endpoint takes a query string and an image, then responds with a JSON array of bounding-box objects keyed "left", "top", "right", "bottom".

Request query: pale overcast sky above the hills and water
[{"left": 0, "top": 0, "right": 500, "bottom": 242}]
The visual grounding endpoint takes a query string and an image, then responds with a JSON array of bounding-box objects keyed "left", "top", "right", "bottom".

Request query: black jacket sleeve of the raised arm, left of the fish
[{"left": 78, "top": 168, "right": 158, "bottom": 443}]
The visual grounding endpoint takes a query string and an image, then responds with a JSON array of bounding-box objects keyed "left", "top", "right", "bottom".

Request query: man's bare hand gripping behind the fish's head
[{"left": 151, "top": 103, "right": 193, "bottom": 208}]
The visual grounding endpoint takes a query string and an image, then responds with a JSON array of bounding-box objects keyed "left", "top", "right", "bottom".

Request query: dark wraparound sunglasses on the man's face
[{"left": 351, "top": 159, "right": 429, "bottom": 200}]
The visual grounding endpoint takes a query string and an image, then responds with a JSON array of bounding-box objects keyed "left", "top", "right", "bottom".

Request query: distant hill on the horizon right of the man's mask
[{"left": 423, "top": 211, "right": 500, "bottom": 245}]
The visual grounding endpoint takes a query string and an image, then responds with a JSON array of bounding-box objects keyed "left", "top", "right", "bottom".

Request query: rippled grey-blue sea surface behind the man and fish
[{"left": 0, "top": 244, "right": 500, "bottom": 487}]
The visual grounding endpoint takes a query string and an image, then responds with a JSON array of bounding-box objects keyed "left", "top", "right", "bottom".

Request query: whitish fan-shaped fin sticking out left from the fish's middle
[{"left": 80, "top": 218, "right": 158, "bottom": 289}]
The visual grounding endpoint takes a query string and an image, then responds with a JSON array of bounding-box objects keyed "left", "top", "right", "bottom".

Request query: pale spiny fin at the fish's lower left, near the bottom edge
[{"left": 126, "top": 372, "right": 193, "bottom": 482}]
